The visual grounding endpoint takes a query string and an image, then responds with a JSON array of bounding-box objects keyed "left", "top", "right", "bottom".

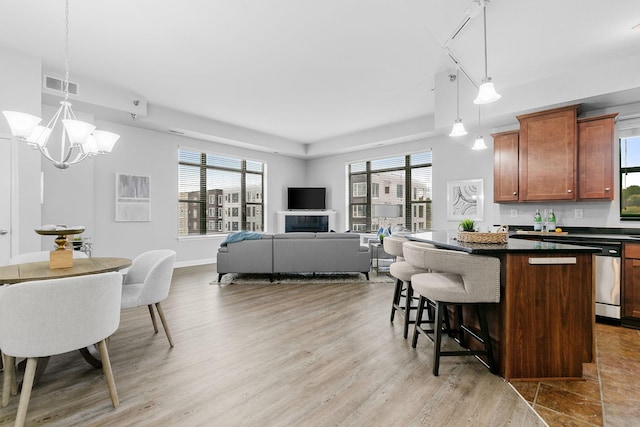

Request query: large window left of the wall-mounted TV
[{"left": 178, "top": 148, "right": 264, "bottom": 236}]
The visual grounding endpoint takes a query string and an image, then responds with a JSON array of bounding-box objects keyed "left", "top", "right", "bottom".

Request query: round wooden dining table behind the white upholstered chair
[{"left": 0, "top": 257, "right": 131, "bottom": 380}]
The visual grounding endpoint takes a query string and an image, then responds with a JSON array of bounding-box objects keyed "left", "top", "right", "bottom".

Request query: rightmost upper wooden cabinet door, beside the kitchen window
[{"left": 578, "top": 114, "right": 617, "bottom": 200}]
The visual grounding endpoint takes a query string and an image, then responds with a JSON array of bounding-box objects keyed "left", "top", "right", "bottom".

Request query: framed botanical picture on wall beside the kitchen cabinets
[{"left": 447, "top": 179, "right": 484, "bottom": 221}]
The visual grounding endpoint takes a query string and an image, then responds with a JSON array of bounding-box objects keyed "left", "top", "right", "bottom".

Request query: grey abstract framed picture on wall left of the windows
[{"left": 115, "top": 173, "right": 151, "bottom": 222}]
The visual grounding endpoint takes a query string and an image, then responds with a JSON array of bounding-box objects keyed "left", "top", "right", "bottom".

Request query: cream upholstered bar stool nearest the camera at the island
[{"left": 404, "top": 242, "right": 500, "bottom": 376}]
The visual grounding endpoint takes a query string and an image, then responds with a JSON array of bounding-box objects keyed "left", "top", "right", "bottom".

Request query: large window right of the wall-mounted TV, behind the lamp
[{"left": 348, "top": 151, "right": 432, "bottom": 232}]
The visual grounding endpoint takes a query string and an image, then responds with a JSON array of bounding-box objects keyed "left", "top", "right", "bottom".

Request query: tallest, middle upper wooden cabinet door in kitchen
[{"left": 517, "top": 105, "right": 579, "bottom": 201}]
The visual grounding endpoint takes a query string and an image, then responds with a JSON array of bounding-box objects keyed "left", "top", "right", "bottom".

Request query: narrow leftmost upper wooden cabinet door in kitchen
[{"left": 491, "top": 130, "right": 519, "bottom": 203}]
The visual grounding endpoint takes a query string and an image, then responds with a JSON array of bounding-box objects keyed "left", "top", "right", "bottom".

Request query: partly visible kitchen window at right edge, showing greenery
[{"left": 620, "top": 136, "right": 640, "bottom": 220}]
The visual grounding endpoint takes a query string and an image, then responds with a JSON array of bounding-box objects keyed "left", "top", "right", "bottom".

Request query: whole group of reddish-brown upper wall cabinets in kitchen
[{"left": 492, "top": 105, "right": 617, "bottom": 203}]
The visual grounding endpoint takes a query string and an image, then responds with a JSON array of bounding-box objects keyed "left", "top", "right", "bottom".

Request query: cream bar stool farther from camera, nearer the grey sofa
[{"left": 383, "top": 236, "right": 434, "bottom": 338}]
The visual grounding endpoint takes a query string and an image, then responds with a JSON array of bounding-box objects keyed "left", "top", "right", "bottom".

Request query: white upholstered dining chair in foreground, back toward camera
[{"left": 0, "top": 272, "right": 122, "bottom": 426}]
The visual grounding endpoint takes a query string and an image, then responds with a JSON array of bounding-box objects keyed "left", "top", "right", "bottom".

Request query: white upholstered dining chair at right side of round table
[{"left": 122, "top": 249, "right": 176, "bottom": 347}]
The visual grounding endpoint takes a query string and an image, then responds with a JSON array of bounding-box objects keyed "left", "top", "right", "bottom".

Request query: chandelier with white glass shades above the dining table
[{"left": 2, "top": 0, "right": 120, "bottom": 169}]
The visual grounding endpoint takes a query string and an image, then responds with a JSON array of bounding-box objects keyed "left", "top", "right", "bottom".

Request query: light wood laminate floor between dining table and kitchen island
[{"left": 0, "top": 266, "right": 544, "bottom": 426}]
